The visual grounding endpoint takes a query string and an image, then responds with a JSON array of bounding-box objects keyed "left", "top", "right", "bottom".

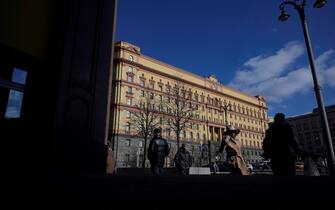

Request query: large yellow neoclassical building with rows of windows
[{"left": 110, "top": 41, "right": 268, "bottom": 167}]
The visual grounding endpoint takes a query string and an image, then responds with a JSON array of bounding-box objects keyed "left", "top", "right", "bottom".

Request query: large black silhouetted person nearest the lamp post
[{"left": 263, "top": 113, "right": 305, "bottom": 176}]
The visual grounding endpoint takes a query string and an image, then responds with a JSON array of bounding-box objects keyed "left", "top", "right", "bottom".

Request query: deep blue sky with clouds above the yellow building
[{"left": 116, "top": 0, "right": 335, "bottom": 116}]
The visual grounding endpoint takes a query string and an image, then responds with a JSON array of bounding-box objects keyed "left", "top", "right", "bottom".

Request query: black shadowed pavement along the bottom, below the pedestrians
[{"left": 17, "top": 174, "right": 335, "bottom": 210}]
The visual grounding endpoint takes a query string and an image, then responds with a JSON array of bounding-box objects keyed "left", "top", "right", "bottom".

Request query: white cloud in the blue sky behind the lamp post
[{"left": 229, "top": 42, "right": 335, "bottom": 103}]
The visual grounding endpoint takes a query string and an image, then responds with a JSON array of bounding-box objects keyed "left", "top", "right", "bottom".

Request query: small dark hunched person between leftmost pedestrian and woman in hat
[{"left": 174, "top": 144, "right": 193, "bottom": 175}]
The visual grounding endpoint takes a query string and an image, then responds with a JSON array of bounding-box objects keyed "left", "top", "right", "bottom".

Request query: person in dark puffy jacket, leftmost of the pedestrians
[{"left": 148, "top": 128, "right": 170, "bottom": 175}]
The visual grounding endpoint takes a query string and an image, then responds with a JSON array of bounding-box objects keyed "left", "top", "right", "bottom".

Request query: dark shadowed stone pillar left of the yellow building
[{"left": 52, "top": 0, "right": 116, "bottom": 173}]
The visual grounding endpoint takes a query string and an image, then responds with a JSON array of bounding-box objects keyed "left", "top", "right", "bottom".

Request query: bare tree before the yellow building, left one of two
[{"left": 129, "top": 92, "right": 162, "bottom": 168}]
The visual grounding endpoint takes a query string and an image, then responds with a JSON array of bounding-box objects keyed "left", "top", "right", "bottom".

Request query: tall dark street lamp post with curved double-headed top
[{"left": 278, "top": 0, "right": 335, "bottom": 175}]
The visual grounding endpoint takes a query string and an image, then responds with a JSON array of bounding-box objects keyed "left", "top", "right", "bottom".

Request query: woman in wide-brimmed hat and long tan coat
[{"left": 219, "top": 125, "right": 250, "bottom": 175}]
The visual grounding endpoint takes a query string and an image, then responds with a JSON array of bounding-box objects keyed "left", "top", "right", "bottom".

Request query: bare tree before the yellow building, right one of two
[{"left": 165, "top": 84, "right": 198, "bottom": 148}]
